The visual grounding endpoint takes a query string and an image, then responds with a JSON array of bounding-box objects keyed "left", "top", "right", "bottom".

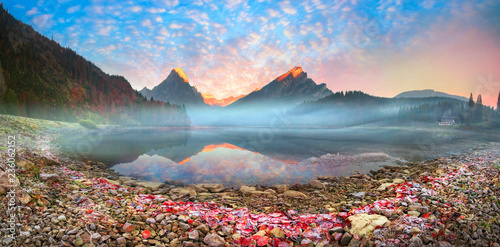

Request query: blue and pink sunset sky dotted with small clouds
[{"left": 3, "top": 0, "right": 500, "bottom": 105}]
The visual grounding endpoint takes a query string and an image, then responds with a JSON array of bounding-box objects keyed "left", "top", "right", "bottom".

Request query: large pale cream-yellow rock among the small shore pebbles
[{"left": 347, "top": 213, "right": 389, "bottom": 238}]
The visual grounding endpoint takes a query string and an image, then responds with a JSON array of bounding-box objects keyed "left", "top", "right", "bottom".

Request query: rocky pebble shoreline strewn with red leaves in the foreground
[{"left": 0, "top": 115, "right": 500, "bottom": 246}]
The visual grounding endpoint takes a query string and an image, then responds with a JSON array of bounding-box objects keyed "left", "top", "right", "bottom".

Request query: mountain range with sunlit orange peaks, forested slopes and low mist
[{"left": 0, "top": 4, "right": 488, "bottom": 126}]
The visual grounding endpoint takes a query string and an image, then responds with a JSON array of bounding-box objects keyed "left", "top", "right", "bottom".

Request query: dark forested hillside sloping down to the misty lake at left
[{"left": 0, "top": 5, "right": 190, "bottom": 126}]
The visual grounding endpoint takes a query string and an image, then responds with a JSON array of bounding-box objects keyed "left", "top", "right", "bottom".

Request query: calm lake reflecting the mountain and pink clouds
[{"left": 58, "top": 126, "right": 498, "bottom": 186}]
